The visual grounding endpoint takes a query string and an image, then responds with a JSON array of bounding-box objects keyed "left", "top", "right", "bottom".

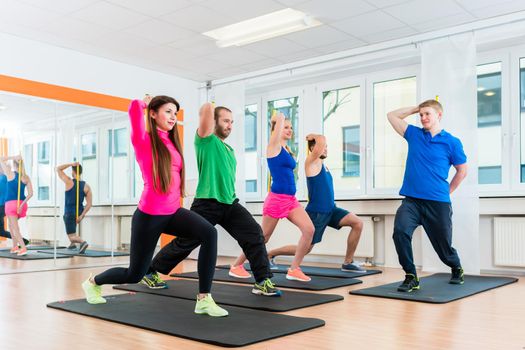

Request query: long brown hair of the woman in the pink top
[{"left": 147, "top": 96, "right": 185, "bottom": 197}]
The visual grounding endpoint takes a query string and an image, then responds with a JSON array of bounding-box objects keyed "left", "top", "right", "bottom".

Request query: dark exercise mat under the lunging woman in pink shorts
[{"left": 171, "top": 269, "right": 363, "bottom": 290}]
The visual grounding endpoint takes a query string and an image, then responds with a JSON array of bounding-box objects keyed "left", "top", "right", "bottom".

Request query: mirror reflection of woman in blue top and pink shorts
[{"left": 0, "top": 156, "right": 33, "bottom": 256}]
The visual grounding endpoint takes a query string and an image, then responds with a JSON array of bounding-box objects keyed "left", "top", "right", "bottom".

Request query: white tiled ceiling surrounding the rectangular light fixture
[{"left": 0, "top": 0, "right": 525, "bottom": 81}]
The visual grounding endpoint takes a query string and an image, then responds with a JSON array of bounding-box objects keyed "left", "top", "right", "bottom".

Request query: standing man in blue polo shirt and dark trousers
[{"left": 387, "top": 100, "right": 467, "bottom": 292}]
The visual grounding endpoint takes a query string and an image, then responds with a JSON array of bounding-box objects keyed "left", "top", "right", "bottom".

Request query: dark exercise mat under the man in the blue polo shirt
[{"left": 350, "top": 273, "right": 518, "bottom": 304}]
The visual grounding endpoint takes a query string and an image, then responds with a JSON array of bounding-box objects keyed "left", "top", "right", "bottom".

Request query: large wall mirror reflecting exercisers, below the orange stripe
[{"left": 0, "top": 92, "right": 130, "bottom": 273}]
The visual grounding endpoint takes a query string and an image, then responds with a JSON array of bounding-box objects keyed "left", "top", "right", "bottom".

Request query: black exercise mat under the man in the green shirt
[{"left": 113, "top": 280, "right": 344, "bottom": 312}]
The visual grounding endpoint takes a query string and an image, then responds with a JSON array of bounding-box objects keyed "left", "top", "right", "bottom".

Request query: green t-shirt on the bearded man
[{"left": 194, "top": 133, "right": 237, "bottom": 204}]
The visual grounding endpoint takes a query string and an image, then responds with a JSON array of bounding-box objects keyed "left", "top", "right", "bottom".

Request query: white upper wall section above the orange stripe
[{"left": 0, "top": 33, "right": 198, "bottom": 105}]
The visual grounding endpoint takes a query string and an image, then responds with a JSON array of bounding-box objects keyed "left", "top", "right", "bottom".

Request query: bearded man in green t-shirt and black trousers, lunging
[{"left": 142, "top": 103, "right": 281, "bottom": 296}]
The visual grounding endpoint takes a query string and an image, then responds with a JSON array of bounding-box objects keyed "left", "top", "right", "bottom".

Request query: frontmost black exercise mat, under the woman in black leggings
[{"left": 47, "top": 293, "right": 325, "bottom": 347}]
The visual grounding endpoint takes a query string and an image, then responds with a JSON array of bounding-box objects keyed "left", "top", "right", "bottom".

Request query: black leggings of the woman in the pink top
[{"left": 95, "top": 208, "right": 217, "bottom": 293}]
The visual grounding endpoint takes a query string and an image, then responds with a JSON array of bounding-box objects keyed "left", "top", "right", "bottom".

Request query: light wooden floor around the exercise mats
[{"left": 0, "top": 259, "right": 525, "bottom": 350}]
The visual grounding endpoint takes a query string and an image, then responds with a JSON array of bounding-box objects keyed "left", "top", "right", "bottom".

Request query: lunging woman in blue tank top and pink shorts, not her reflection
[{"left": 229, "top": 113, "right": 314, "bottom": 282}]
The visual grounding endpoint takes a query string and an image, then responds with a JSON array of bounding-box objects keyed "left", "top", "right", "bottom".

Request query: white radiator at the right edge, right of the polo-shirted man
[{"left": 494, "top": 217, "right": 525, "bottom": 267}]
